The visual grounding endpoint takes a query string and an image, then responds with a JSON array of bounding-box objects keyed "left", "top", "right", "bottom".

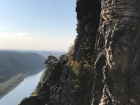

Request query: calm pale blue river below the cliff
[{"left": 0, "top": 70, "right": 44, "bottom": 105}]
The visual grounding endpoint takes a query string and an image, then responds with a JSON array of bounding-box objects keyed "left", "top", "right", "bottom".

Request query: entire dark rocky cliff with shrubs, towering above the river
[{"left": 19, "top": 0, "right": 140, "bottom": 105}]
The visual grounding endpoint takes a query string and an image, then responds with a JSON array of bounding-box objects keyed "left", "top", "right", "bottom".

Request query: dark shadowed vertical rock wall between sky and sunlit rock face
[{"left": 71, "top": 0, "right": 101, "bottom": 61}]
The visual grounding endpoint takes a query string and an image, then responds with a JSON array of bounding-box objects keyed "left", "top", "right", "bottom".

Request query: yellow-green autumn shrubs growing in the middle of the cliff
[{"left": 67, "top": 37, "right": 96, "bottom": 98}]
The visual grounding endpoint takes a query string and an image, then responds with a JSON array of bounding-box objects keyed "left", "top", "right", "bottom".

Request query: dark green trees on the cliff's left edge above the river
[{"left": 34, "top": 54, "right": 68, "bottom": 95}]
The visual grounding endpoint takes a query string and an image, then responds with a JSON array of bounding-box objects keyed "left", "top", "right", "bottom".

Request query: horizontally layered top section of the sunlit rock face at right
[{"left": 101, "top": 0, "right": 140, "bottom": 20}]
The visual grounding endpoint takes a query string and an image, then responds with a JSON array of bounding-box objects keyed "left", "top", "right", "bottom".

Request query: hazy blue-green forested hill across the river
[{"left": 0, "top": 51, "right": 46, "bottom": 83}]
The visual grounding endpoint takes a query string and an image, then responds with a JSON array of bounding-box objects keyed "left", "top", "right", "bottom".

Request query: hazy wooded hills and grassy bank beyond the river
[{"left": 0, "top": 50, "right": 65, "bottom": 98}]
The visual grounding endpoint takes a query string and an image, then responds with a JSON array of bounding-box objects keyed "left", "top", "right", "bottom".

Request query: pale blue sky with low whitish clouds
[{"left": 0, "top": 0, "right": 77, "bottom": 51}]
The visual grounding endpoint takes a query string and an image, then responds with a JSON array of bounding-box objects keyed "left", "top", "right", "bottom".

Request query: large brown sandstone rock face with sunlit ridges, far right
[{"left": 92, "top": 0, "right": 140, "bottom": 105}]
